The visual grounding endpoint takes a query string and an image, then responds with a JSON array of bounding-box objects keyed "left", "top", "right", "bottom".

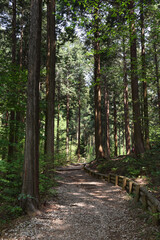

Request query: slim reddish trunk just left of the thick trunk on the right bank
[{"left": 123, "top": 37, "right": 131, "bottom": 154}]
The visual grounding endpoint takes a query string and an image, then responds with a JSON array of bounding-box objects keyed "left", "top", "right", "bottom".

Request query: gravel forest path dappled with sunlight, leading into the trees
[{"left": 0, "top": 166, "right": 159, "bottom": 240}]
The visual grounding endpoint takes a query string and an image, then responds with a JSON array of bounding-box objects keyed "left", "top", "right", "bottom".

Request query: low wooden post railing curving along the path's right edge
[{"left": 84, "top": 166, "right": 160, "bottom": 225}]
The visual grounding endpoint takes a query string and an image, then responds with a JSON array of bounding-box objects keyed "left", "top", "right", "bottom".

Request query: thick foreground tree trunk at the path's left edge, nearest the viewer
[{"left": 21, "top": 0, "right": 41, "bottom": 212}]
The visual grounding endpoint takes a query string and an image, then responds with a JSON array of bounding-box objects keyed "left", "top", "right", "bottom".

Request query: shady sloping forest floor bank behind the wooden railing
[{"left": 89, "top": 150, "right": 160, "bottom": 201}]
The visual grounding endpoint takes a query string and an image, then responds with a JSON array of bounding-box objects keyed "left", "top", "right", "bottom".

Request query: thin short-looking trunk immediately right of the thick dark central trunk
[{"left": 104, "top": 85, "right": 110, "bottom": 159}]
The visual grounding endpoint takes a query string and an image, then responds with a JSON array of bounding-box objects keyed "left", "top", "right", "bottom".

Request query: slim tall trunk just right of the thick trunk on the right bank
[{"left": 140, "top": 0, "right": 150, "bottom": 149}]
